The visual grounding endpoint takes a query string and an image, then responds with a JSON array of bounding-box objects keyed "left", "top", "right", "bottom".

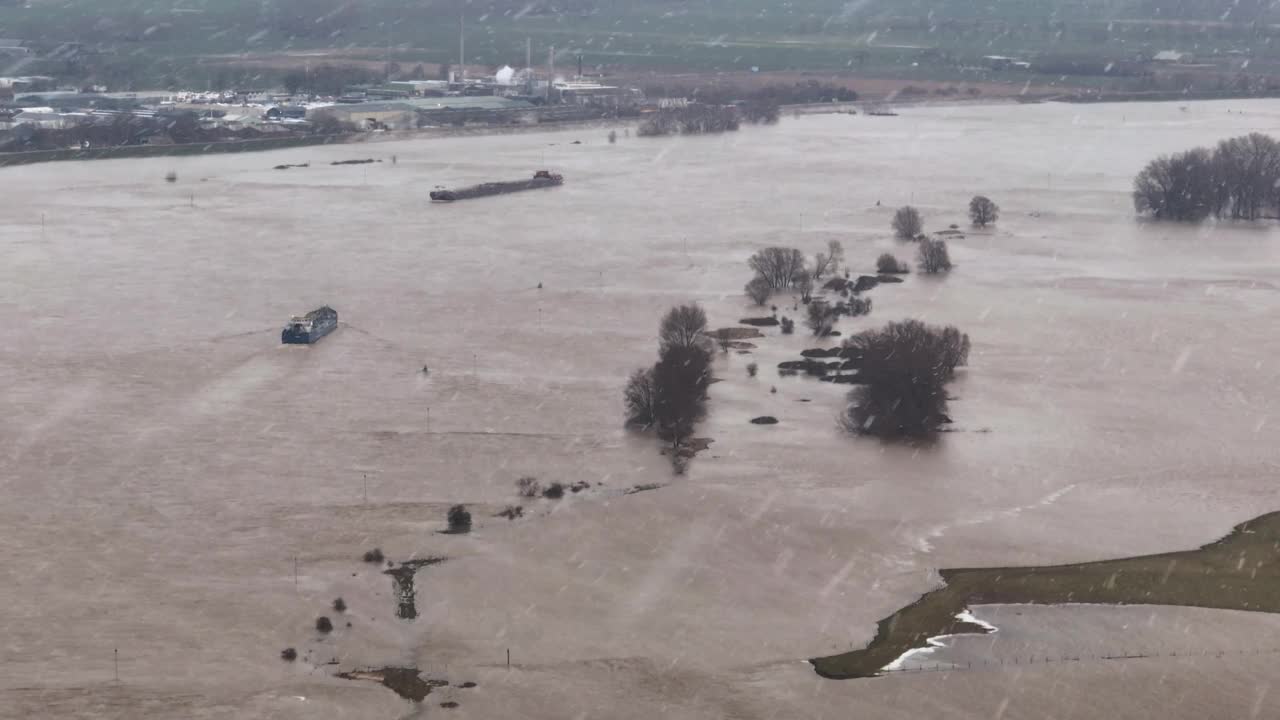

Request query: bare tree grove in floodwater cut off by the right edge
[{"left": 1133, "top": 132, "right": 1280, "bottom": 222}]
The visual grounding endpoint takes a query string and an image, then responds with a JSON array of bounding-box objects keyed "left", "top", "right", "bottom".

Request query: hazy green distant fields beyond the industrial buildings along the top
[{"left": 0, "top": 0, "right": 1280, "bottom": 85}]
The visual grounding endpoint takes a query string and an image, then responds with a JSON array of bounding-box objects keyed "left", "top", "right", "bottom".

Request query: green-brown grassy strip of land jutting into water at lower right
[{"left": 812, "top": 512, "right": 1280, "bottom": 679}]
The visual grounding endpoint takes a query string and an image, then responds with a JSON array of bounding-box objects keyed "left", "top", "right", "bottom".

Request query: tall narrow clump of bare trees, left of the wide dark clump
[{"left": 622, "top": 305, "right": 712, "bottom": 459}]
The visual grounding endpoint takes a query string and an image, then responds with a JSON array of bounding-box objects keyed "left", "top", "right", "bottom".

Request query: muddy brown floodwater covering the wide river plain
[{"left": 0, "top": 101, "right": 1280, "bottom": 719}]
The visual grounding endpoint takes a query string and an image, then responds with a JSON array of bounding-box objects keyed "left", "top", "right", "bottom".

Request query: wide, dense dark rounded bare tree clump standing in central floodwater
[{"left": 841, "top": 320, "right": 969, "bottom": 438}]
